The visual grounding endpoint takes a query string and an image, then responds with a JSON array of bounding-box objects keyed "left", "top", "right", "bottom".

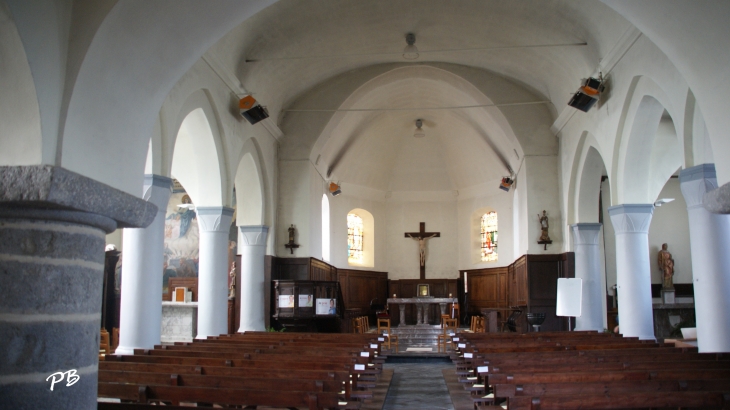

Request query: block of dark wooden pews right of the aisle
[{"left": 451, "top": 332, "right": 730, "bottom": 410}]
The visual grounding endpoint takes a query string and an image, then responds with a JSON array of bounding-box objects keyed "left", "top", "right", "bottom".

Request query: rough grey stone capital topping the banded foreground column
[{"left": 0, "top": 165, "right": 157, "bottom": 232}]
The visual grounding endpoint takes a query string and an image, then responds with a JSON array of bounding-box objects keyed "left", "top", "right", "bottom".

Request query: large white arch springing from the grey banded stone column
[{"left": 59, "top": 0, "right": 274, "bottom": 195}]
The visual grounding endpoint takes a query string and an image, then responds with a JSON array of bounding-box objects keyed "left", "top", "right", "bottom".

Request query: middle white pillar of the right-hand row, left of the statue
[{"left": 608, "top": 204, "right": 656, "bottom": 340}]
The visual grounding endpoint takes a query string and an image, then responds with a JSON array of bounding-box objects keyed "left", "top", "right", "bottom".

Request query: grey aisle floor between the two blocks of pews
[{"left": 383, "top": 363, "right": 454, "bottom": 410}]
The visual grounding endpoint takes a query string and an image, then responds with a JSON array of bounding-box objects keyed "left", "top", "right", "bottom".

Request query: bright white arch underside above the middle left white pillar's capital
[{"left": 171, "top": 90, "right": 231, "bottom": 206}]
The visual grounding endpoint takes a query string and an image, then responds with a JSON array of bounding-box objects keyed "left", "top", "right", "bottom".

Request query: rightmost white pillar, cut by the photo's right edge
[{"left": 679, "top": 164, "right": 730, "bottom": 353}]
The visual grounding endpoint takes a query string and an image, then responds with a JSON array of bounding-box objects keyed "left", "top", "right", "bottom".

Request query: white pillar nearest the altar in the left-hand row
[{"left": 238, "top": 225, "right": 269, "bottom": 332}]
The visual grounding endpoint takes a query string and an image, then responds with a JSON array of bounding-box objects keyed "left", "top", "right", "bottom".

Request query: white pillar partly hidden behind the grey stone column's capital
[{"left": 115, "top": 175, "right": 172, "bottom": 355}]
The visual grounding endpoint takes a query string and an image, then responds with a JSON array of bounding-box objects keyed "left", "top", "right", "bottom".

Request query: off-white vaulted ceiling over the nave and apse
[{"left": 202, "top": 0, "right": 632, "bottom": 191}]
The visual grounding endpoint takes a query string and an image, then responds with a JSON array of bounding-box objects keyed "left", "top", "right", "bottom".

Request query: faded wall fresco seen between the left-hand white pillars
[{"left": 162, "top": 192, "right": 200, "bottom": 294}]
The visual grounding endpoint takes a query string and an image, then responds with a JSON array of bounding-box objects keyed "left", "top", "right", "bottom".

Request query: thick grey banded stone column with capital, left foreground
[{"left": 0, "top": 166, "right": 156, "bottom": 410}]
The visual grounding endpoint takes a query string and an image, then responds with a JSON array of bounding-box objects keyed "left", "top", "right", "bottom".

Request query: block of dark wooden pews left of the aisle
[{"left": 98, "top": 332, "right": 385, "bottom": 410}]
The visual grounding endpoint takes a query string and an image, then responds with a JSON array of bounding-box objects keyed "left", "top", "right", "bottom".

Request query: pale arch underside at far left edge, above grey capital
[{"left": 0, "top": 2, "right": 41, "bottom": 165}]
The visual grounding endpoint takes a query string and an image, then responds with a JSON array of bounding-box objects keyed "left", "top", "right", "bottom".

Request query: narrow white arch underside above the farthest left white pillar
[{"left": 235, "top": 138, "right": 266, "bottom": 226}]
